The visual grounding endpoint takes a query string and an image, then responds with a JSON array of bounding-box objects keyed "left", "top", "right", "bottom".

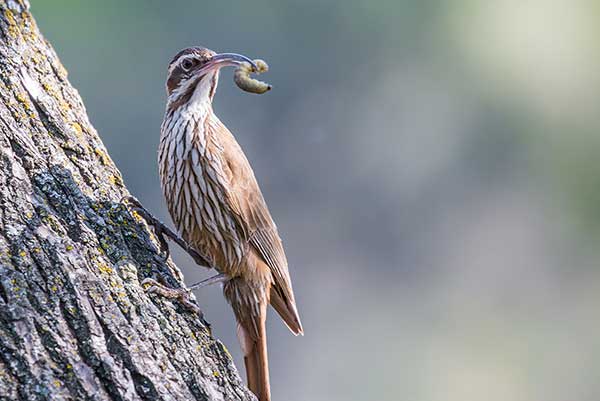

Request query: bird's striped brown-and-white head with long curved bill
[{"left": 167, "top": 47, "right": 257, "bottom": 111}]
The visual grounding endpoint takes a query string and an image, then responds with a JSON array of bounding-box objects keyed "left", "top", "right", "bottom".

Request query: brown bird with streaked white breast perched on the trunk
[{"left": 149, "top": 47, "right": 303, "bottom": 401}]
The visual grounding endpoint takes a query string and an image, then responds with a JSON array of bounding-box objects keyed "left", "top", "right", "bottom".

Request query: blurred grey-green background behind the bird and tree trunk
[{"left": 31, "top": 0, "right": 600, "bottom": 401}]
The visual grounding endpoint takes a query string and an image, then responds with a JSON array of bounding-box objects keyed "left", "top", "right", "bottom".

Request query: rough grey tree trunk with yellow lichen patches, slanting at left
[{"left": 0, "top": 0, "right": 254, "bottom": 400}]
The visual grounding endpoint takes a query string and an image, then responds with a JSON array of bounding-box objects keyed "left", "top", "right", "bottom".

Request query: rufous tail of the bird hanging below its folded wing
[{"left": 237, "top": 303, "right": 271, "bottom": 401}]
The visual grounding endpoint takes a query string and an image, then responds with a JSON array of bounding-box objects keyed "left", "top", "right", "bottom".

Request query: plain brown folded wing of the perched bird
[{"left": 213, "top": 120, "right": 302, "bottom": 334}]
